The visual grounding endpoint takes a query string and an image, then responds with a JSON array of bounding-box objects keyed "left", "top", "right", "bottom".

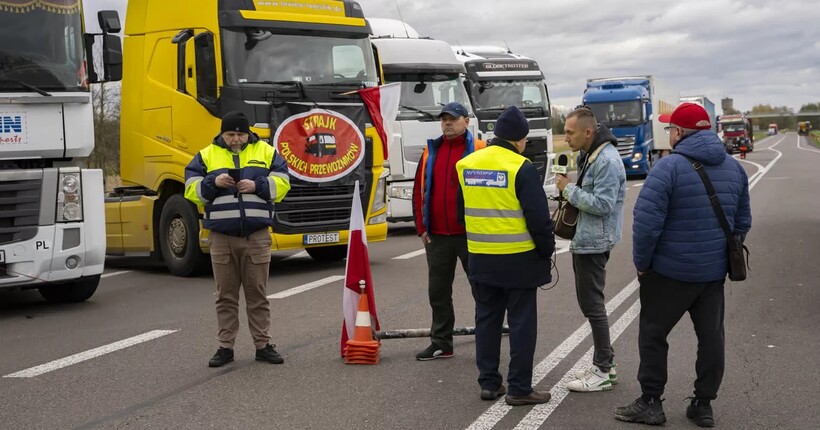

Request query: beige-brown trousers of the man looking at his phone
[{"left": 210, "top": 229, "right": 271, "bottom": 349}]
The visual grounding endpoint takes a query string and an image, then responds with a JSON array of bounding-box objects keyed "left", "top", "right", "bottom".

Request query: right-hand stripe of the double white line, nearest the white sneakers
[{"left": 515, "top": 300, "right": 641, "bottom": 430}]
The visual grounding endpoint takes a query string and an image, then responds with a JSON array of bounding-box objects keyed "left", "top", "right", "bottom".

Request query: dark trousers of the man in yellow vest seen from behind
[{"left": 473, "top": 284, "right": 538, "bottom": 396}]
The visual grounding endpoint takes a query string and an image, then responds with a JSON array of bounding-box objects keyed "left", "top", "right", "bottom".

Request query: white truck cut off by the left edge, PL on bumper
[{"left": 0, "top": 5, "right": 122, "bottom": 302}]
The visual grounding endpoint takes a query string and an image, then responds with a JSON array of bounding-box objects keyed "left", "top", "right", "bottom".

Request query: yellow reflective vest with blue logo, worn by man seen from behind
[{"left": 456, "top": 146, "right": 535, "bottom": 254}]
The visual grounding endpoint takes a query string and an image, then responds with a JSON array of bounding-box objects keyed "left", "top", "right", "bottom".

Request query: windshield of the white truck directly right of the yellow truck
[{"left": 384, "top": 73, "right": 470, "bottom": 121}]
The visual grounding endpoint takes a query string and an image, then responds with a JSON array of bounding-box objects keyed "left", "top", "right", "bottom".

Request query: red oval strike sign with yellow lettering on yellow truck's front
[{"left": 273, "top": 109, "right": 364, "bottom": 182}]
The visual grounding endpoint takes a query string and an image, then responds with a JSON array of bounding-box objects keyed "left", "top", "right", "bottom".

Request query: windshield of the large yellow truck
[{"left": 222, "top": 29, "right": 378, "bottom": 87}]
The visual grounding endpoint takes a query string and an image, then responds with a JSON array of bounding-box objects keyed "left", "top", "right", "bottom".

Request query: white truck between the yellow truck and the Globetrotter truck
[{"left": 368, "top": 18, "right": 476, "bottom": 222}]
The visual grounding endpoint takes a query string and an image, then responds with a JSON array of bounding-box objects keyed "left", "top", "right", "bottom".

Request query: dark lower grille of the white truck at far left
[{"left": 0, "top": 179, "right": 43, "bottom": 244}]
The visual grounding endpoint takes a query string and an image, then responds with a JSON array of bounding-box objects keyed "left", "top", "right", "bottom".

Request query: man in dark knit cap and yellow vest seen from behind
[{"left": 456, "top": 106, "right": 555, "bottom": 406}]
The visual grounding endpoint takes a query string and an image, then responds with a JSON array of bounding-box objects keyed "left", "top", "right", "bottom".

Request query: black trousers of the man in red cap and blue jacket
[{"left": 638, "top": 271, "right": 725, "bottom": 400}]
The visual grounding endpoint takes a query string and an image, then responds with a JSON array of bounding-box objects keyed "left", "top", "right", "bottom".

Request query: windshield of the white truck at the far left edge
[{"left": 0, "top": 0, "right": 88, "bottom": 91}]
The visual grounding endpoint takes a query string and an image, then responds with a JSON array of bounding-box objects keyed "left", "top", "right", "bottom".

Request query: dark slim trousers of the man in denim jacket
[{"left": 572, "top": 252, "right": 615, "bottom": 372}]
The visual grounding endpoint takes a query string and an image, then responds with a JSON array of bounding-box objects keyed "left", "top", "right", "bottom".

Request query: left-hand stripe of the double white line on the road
[{"left": 467, "top": 278, "right": 639, "bottom": 430}]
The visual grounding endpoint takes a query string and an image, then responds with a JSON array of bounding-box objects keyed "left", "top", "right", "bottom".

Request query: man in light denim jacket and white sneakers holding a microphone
[{"left": 556, "top": 107, "right": 626, "bottom": 392}]
